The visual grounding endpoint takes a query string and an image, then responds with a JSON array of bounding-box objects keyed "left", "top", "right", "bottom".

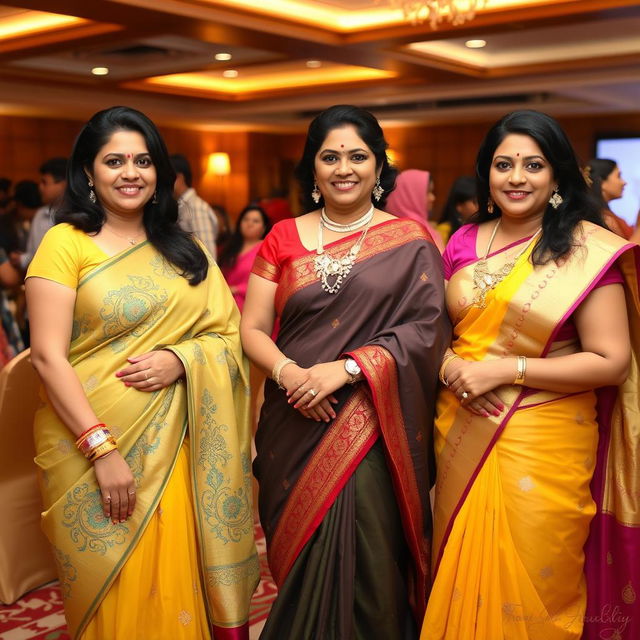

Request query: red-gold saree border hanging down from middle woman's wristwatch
[{"left": 346, "top": 345, "right": 431, "bottom": 620}]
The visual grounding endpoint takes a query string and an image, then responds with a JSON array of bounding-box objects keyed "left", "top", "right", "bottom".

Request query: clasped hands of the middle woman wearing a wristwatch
[{"left": 280, "top": 360, "right": 349, "bottom": 422}]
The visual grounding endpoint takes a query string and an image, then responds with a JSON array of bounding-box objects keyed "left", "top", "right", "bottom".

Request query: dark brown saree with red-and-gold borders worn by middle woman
[{"left": 254, "top": 220, "right": 450, "bottom": 640}]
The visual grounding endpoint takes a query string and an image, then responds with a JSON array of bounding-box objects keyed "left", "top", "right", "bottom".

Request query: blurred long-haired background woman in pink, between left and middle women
[{"left": 218, "top": 205, "right": 271, "bottom": 312}]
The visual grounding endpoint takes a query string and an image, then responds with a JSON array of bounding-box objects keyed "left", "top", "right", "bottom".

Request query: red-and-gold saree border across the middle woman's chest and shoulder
[{"left": 274, "top": 220, "right": 433, "bottom": 315}]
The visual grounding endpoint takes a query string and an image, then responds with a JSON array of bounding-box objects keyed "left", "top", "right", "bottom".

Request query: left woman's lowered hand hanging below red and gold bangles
[{"left": 93, "top": 450, "right": 136, "bottom": 524}]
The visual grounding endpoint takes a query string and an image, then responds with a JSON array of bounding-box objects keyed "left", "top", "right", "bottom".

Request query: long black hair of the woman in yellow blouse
[{"left": 55, "top": 107, "right": 209, "bottom": 285}]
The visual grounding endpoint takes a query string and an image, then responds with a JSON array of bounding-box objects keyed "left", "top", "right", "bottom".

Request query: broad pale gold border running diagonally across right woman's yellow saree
[{"left": 433, "top": 222, "right": 633, "bottom": 574}]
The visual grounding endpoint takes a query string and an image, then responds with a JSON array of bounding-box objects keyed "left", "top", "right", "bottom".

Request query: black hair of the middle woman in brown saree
[{"left": 295, "top": 104, "right": 398, "bottom": 213}]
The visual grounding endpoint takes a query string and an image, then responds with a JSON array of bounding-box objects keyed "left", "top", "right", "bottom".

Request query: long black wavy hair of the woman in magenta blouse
[{"left": 473, "top": 110, "right": 606, "bottom": 265}]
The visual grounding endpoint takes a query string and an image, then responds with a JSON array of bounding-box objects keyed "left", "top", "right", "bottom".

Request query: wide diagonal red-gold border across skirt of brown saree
[{"left": 268, "top": 386, "right": 379, "bottom": 586}]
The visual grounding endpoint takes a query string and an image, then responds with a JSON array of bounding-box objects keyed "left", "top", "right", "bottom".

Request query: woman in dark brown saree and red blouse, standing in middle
[{"left": 241, "top": 106, "right": 450, "bottom": 640}]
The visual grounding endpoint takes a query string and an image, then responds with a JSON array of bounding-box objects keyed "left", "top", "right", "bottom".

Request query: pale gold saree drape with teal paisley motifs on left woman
[{"left": 34, "top": 242, "right": 259, "bottom": 638}]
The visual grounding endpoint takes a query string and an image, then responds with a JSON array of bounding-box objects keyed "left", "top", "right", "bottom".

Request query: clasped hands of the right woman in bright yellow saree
[{"left": 444, "top": 358, "right": 516, "bottom": 417}]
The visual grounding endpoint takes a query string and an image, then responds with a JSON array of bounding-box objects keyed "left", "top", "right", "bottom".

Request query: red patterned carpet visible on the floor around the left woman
[{"left": 0, "top": 526, "right": 276, "bottom": 640}]
